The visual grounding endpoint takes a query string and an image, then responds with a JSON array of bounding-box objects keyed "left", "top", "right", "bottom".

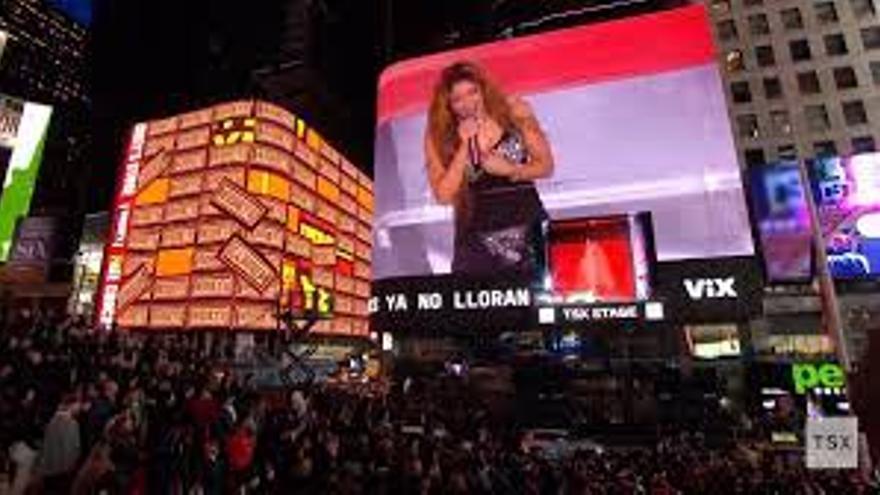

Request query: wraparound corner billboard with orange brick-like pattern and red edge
[{"left": 98, "top": 101, "right": 373, "bottom": 336}]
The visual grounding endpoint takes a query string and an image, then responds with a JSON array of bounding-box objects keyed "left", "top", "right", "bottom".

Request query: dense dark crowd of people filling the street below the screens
[{"left": 0, "top": 312, "right": 877, "bottom": 495}]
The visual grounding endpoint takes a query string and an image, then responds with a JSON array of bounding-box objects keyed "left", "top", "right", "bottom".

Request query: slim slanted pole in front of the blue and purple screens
[{"left": 798, "top": 160, "right": 852, "bottom": 374}]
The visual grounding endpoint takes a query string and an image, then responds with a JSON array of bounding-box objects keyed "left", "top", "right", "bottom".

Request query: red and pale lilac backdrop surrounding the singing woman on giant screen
[{"left": 373, "top": 6, "right": 753, "bottom": 279}]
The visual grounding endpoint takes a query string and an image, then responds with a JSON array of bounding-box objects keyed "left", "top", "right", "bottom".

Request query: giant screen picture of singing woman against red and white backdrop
[{"left": 373, "top": 6, "right": 754, "bottom": 286}]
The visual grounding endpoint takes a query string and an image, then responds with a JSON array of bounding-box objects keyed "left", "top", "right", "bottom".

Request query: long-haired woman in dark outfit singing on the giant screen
[{"left": 425, "top": 62, "right": 553, "bottom": 280}]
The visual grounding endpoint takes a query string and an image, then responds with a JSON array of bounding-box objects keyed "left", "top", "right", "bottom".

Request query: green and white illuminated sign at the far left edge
[{"left": 0, "top": 102, "right": 52, "bottom": 263}]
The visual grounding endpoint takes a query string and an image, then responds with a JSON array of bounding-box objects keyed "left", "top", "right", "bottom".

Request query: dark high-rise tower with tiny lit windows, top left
[{"left": 0, "top": 0, "right": 91, "bottom": 264}]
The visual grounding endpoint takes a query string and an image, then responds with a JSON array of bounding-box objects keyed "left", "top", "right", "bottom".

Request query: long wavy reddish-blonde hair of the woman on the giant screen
[{"left": 428, "top": 61, "right": 518, "bottom": 218}]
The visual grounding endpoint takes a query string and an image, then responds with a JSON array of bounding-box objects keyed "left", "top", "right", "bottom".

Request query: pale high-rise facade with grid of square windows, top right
[{"left": 708, "top": 0, "right": 880, "bottom": 166}]
